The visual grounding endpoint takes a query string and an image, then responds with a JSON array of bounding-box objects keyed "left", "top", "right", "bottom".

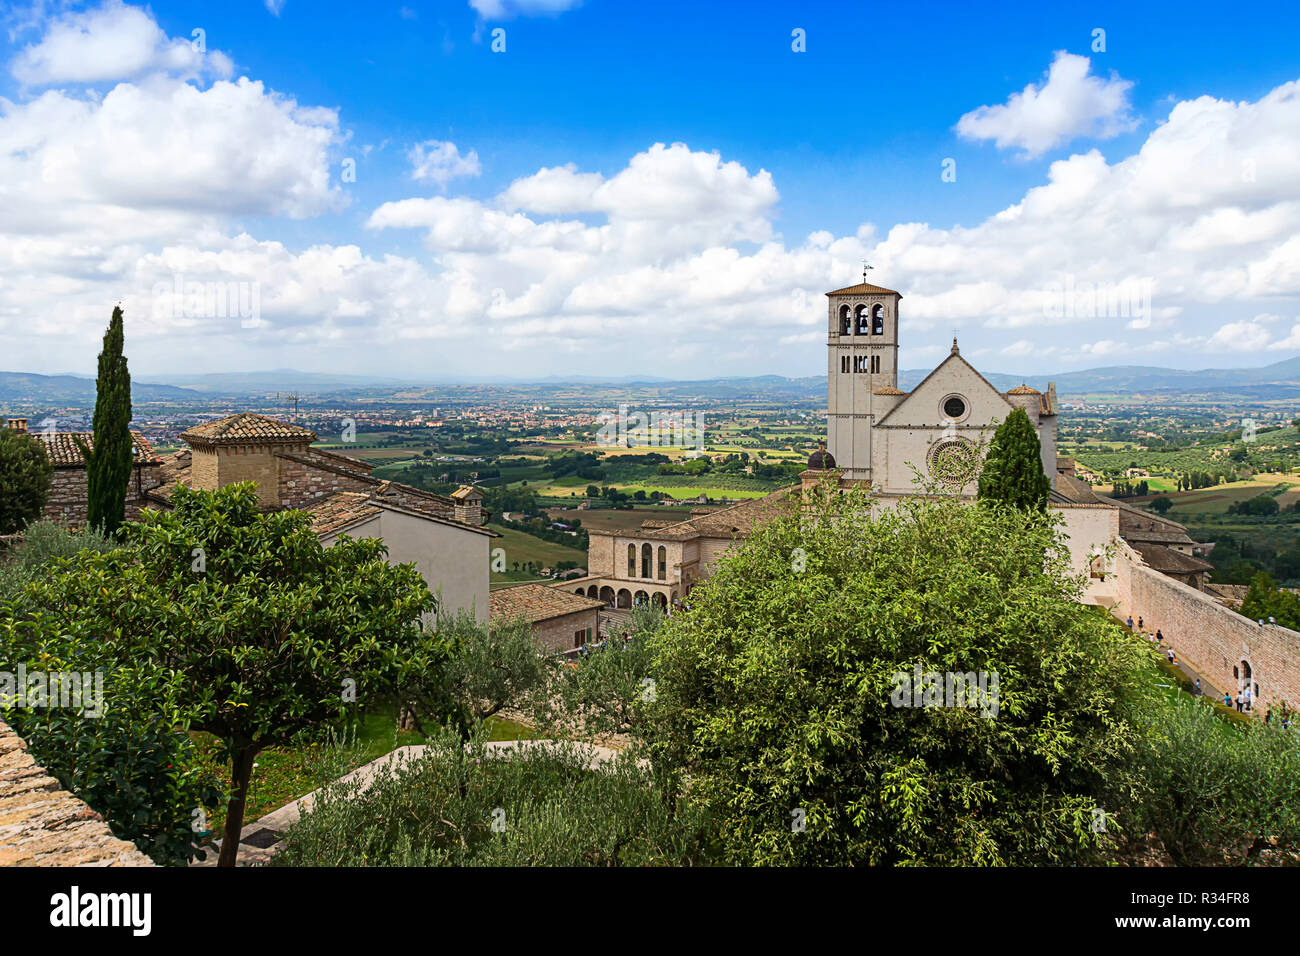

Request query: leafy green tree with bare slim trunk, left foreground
[{"left": 22, "top": 484, "right": 449, "bottom": 866}]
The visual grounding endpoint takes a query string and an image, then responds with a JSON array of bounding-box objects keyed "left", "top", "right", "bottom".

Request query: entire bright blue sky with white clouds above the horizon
[{"left": 0, "top": 0, "right": 1300, "bottom": 378}]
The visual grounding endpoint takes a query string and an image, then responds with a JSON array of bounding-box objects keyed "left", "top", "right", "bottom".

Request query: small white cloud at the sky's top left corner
[{"left": 10, "top": 0, "right": 233, "bottom": 86}]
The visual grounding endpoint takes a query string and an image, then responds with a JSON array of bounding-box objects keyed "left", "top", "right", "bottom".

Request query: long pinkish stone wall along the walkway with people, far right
[{"left": 1117, "top": 542, "right": 1300, "bottom": 706}]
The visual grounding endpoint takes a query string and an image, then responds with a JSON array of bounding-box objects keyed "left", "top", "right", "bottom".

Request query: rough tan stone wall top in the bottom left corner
[{"left": 0, "top": 721, "right": 153, "bottom": 866}]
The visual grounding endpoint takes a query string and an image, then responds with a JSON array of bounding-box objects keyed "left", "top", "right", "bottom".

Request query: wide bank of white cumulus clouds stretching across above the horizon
[{"left": 0, "top": 8, "right": 1300, "bottom": 377}]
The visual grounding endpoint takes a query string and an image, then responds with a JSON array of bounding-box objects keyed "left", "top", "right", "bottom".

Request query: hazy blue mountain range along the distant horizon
[{"left": 0, "top": 358, "right": 1300, "bottom": 405}]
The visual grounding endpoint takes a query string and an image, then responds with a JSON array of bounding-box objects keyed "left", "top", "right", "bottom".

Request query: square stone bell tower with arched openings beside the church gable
[{"left": 826, "top": 274, "right": 902, "bottom": 481}]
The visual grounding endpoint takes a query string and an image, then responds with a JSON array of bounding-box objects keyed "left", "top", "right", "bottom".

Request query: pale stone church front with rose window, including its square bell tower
[{"left": 803, "top": 282, "right": 1057, "bottom": 503}]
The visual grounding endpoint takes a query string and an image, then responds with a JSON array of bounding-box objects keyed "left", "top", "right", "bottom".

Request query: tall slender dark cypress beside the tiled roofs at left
[{"left": 77, "top": 306, "right": 135, "bottom": 535}]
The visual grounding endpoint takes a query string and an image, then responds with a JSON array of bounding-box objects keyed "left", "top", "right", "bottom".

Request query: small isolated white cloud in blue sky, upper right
[{"left": 957, "top": 51, "right": 1138, "bottom": 159}]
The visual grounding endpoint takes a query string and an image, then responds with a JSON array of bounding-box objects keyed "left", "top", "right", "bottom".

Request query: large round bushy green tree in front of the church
[{"left": 644, "top": 489, "right": 1149, "bottom": 865}]
